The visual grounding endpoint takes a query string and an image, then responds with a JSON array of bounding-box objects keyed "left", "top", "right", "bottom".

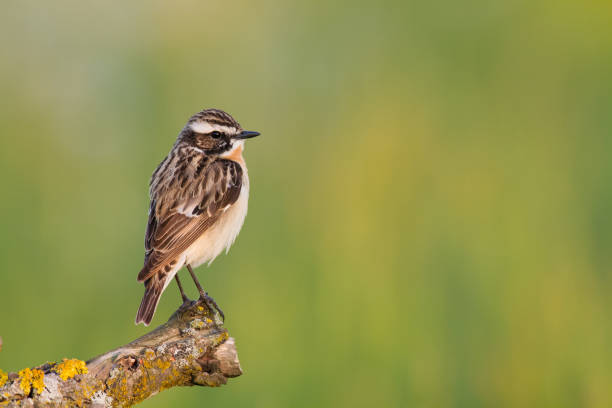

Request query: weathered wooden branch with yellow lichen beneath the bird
[{"left": 0, "top": 301, "right": 242, "bottom": 408}]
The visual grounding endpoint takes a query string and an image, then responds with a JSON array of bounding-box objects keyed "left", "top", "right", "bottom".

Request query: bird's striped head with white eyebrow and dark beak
[{"left": 179, "top": 109, "right": 259, "bottom": 157}]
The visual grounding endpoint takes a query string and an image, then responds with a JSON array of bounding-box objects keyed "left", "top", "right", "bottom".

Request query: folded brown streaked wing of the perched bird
[{"left": 138, "top": 160, "right": 242, "bottom": 282}]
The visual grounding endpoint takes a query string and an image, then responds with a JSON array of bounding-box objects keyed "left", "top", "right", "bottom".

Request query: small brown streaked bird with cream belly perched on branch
[{"left": 135, "top": 109, "right": 260, "bottom": 326}]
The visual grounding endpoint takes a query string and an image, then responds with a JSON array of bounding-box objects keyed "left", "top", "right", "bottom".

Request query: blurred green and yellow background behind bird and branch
[{"left": 0, "top": 0, "right": 612, "bottom": 407}]
